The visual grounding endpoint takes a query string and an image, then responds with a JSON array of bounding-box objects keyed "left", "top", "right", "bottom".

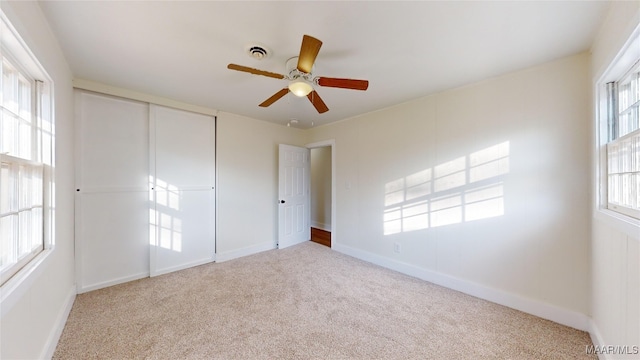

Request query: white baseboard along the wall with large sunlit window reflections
[{"left": 332, "top": 243, "right": 590, "bottom": 331}]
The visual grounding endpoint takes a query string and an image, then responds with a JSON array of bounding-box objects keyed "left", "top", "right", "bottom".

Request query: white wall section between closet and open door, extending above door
[{"left": 216, "top": 113, "right": 305, "bottom": 261}]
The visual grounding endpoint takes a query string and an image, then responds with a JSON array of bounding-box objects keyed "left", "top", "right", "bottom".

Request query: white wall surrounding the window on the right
[{"left": 591, "top": 1, "right": 640, "bottom": 358}]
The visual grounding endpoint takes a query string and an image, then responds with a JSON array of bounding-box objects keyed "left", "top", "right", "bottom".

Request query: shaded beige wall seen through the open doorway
[{"left": 311, "top": 146, "right": 331, "bottom": 231}]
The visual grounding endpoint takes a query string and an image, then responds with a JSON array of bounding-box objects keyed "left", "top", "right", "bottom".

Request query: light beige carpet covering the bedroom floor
[{"left": 54, "top": 242, "right": 592, "bottom": 360}]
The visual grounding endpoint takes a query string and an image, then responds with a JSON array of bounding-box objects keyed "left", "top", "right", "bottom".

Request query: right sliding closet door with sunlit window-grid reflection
[{"left": 150, "top": 105, "right": 215, "bottom": 276}]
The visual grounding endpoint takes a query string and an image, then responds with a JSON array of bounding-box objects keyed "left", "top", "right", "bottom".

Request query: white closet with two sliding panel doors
[{"left": 75, "top": 90, "right": 215, "bottom": 293}]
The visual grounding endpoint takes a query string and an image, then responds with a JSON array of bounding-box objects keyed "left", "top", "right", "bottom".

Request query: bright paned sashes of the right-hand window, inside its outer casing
[{"left": 607, "top": 63, "right": 640, "bottom": 219}]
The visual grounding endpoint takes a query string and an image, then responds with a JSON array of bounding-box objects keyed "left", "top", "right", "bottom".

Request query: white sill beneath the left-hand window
[{"left": 0, "top": 248, "right": 54, "bottom": 317}]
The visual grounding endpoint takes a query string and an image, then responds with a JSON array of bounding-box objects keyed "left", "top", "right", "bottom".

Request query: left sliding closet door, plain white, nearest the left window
[{"left": 75, "top": 90, "right": 149, "bottom": 293}]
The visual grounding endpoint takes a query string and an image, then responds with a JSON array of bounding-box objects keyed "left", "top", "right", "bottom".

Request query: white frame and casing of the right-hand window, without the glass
[{"left": 594, "top": 21, "right": 640, "bottom": 236}]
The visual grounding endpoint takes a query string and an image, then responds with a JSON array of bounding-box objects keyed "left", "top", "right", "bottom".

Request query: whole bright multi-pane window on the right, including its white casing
[{"left": 596, "top": 21, "right": 640, "bottom": 222}]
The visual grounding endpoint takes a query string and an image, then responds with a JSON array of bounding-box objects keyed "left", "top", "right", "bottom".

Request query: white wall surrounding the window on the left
[{"left": 0, "top": 1, "right": 75, "bottom": 359}]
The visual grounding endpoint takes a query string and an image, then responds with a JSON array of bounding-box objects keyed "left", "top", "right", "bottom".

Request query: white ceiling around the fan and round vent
[{"left": 41, "top": 1, "right": 608, "bottom": 128}]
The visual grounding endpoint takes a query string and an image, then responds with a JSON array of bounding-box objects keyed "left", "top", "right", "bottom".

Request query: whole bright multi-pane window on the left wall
[{"left": 0, "top": 13, "right": 53, "bottom": 284}]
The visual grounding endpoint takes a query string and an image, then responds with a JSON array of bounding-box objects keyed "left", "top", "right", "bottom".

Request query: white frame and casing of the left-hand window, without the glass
[{"left": 0, "top": 10, "right": 55, "bottom": 290}]
